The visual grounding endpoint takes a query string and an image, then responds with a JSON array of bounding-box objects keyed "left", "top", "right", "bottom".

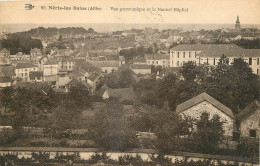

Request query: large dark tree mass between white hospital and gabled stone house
[{"left": 204, "top": 56, "right": 259, "bottom": 114}]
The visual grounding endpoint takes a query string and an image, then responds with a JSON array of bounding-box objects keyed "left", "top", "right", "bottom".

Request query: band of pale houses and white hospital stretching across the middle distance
[{"left": 0, "top": 41, "right": 260, "bottom": 90}]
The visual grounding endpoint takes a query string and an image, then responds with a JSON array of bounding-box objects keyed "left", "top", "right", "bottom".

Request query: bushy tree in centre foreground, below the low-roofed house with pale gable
[{"left": 93, "top": 99, "right": 137, "bottom": 151}]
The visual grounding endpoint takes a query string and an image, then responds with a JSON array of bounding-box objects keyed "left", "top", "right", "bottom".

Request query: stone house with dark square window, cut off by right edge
[{"left": 237, "top": 100, "right": 260, "bottom": 140}]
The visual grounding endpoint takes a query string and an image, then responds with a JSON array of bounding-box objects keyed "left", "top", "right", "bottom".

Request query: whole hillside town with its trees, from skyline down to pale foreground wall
[{"left": 0, "top": 16, "right": 260, "bottom": 165}]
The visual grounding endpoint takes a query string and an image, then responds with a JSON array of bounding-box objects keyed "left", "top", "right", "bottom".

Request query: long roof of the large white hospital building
[{"left": 171, "top": 44, "right": 244, "bottom": 57}]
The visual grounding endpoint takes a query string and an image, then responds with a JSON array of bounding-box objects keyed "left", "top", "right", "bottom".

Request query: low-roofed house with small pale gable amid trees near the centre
[{"left": 97, "top": 85, "right": 135, "bottom": 105}]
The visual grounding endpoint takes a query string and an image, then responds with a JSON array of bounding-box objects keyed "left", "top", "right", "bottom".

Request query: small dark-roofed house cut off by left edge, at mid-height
[{"left": 0, "top": 66, "right": 15, "bottom": 88}]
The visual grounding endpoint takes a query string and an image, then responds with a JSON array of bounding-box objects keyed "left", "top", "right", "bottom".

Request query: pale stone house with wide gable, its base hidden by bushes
[{"left": 176, "top": 93, "right": 235, "bottom": 137}]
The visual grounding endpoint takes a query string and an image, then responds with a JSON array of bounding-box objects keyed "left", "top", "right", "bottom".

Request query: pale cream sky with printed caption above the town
[{"left": 0, "top": 0, "right": 260, "bottom": 24}]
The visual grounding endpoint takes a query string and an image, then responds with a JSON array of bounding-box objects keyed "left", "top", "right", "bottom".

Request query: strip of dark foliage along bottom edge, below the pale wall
[{"left": 0, "top": 153, "right": 243, "bottom": 166}]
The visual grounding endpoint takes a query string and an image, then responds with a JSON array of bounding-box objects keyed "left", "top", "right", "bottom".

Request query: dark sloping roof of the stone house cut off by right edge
[{"left": 237, "top": 100, "right": 260, "bottom": 122}]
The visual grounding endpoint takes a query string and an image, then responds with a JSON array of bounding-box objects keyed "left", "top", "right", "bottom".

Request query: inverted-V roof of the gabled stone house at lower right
[{"left": 176, "top": 93, "right": 234, "bottom": 118}]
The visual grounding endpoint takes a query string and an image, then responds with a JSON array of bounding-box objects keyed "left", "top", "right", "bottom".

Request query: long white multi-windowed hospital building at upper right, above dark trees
[{"left": 170, "top": 44, "right": 260, "bottom": 75}]
